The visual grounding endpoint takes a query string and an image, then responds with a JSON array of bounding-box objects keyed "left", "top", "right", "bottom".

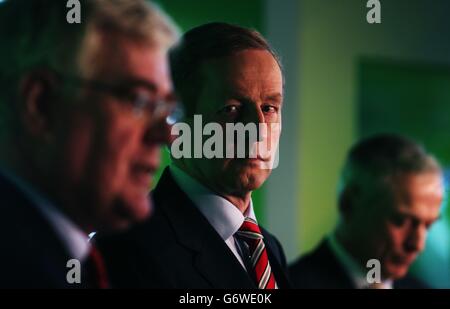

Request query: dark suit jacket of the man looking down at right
[{"left": 289, "top": 240, "right": 427, "bottom": 289}]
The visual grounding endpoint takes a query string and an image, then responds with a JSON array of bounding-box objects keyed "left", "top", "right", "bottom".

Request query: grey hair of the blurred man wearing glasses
[{"left": 0, "top": 0, "right": 179, "bottom": 139}]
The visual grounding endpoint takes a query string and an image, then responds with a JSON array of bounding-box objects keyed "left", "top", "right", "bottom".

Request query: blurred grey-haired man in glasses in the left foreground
[{"left": 0, "top": 0, "right": 177, "bottom": 288}]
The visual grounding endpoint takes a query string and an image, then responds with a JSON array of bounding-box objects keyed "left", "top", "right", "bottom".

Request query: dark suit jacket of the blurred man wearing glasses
[{"left": 0, "top": 174, "right": 73, "bottom": 288}]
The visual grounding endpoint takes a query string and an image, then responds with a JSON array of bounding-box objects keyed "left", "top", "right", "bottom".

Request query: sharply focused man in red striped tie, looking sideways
[{"left": 99, "top": 23, "right": 288, "bottom": 289}]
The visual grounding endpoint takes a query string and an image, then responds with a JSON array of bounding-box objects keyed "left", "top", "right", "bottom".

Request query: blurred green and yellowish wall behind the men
[{"left": 155, "top": 0, "right": 450, "bottom": 288}]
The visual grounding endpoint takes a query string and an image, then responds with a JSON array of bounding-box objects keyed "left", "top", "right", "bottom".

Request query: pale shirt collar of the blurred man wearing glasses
[{"left": 0, "top": 169, "right": 90, "bottom": 261}]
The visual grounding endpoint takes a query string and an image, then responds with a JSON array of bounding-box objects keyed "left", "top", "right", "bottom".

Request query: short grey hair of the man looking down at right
[{"left": 338, "top": 134, "right": 442, "bottom": 211}]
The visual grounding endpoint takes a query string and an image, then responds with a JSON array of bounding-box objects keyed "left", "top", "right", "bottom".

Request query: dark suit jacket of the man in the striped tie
[{"left": 96, "top": 169, "right": 288, "bottom": 288}]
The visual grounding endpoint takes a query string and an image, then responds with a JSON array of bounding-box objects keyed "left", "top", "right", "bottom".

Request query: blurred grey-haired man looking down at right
[{"left": 290, "top": 134, "right": 444, "bottom": 289}]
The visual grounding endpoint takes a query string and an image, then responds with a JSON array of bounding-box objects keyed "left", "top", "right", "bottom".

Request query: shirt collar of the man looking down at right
[{"left": 328, "top": 233, "right": 392, "bottom": 289}]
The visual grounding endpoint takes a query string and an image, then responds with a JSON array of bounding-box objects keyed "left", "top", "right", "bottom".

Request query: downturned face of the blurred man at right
[{"left": 362, "top": 172, "right": 444, "bottom": 279}]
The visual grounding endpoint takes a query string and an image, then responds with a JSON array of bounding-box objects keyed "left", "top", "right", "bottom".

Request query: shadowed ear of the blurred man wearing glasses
[{"left": 19, "top": 71, "right": 58, "bottom": 140}]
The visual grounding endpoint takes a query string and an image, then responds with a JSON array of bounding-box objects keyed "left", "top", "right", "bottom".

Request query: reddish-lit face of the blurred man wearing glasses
[{"left": 51, "top": 34, "right": 172, "bottom": 230}]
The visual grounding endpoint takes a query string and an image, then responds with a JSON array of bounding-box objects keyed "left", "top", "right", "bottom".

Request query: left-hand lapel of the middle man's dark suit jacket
[{"left": 154, "top": 168, "right": 255, "bottom": 288}]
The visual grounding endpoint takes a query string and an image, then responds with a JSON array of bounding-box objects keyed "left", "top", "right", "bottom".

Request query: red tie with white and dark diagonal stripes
[{"left": 236, "top": 218, "right": 275, "bottom": 289}]
